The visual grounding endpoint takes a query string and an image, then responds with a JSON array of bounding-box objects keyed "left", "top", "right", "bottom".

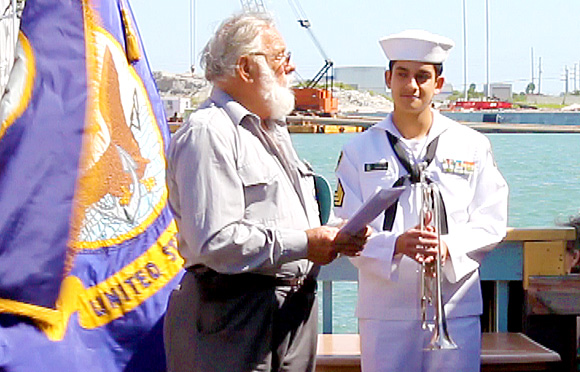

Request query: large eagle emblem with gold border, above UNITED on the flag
[{"left": 72, "top": 30, "right": 167, "bottom": 248}]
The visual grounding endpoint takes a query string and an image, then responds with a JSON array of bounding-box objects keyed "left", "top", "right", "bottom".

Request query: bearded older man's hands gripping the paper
[{"left": 306, "top": 226, "right": 370, "bottom": 265}]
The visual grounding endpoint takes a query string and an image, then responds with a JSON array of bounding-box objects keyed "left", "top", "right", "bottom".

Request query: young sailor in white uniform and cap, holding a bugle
[{"left": 335, "top": 30, "right": 508, "bottom": 372}]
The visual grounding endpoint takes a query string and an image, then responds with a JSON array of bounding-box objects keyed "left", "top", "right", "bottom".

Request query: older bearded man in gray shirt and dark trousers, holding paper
[{"left": 165, "top": 14, "right": 366, "bottom": 372}]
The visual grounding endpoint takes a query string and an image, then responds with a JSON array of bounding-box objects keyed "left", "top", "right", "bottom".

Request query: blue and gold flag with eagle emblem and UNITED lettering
[{"left": 0, "top": 0, "right": 183, "bottom": 371}]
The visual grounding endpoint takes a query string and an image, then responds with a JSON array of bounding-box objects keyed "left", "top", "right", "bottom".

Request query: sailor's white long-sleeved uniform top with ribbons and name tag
[{"left": 335, "top": 111, "right": 508, "bottom": 370}]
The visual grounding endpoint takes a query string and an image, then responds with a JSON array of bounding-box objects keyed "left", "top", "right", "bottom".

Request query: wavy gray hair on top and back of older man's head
[{"left": 201, "top": 13, "right": 275, "bottom": 82}]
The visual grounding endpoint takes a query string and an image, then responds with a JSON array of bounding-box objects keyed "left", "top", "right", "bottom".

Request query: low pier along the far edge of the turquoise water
[{"left": 286, "top": 116, "right": 580, "bottom": 133}]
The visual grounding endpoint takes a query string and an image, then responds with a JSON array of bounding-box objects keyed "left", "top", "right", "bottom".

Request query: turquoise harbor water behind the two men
[{"left": 292, "top": 133, "right": 580, "bottom": 333}]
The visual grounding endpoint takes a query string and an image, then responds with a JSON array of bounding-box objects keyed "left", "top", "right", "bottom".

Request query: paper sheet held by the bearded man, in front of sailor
[{"left": 340, "top": 186, "right": 406, "bottom": 234}]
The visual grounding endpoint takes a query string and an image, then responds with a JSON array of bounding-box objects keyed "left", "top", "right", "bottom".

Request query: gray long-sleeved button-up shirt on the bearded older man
[{"left": 167, "top": 88, "right": 320, "bottom": 277}]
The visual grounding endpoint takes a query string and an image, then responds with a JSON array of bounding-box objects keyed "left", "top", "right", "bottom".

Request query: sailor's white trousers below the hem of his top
[{"left": 359, "top": 316, "right": 481, "bottom": 372}]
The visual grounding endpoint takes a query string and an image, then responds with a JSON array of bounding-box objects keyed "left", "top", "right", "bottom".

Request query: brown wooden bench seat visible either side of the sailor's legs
[{"left": 316, "top": 332, "right": 560, "bottom": 372}]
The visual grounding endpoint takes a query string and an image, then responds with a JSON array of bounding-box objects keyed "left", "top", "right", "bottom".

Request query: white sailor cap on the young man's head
[{"left": 379, "top": 30, "right": 455, "bottom": 63}]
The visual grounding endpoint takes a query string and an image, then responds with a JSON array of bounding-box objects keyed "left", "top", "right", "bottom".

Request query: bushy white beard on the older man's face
[{"left": 259, "top": 61, "right": 295, "bottom": 120}]
